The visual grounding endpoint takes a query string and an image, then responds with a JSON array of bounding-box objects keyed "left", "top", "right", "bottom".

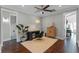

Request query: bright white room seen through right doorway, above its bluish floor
[{"left": 65, "top": 11, "right": 76, "bottom": 43}]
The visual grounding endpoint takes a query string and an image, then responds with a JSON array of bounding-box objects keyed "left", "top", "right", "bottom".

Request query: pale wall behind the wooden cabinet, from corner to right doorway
[{"left": 43, "top": 14, "right": 65, "bottom": 39}]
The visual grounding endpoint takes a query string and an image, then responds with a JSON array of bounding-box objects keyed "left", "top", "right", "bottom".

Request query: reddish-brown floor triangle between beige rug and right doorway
[{"left": 45, "top": 40, "right": 64, "bottom": 53}]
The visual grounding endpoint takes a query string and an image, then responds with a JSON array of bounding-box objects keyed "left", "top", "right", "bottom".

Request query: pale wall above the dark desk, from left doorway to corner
[{"left": 17, "top": 12, "right": 40, "bottom": 41}]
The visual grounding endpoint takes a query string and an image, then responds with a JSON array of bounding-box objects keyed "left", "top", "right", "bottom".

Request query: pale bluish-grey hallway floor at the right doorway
[{"left": 64, "top": 33, "right": 79, "bottom": 53}]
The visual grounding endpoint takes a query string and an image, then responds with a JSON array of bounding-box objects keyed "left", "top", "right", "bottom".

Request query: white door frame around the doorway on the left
[{"left": 1, "top": 8, "right": 18, "bottom": 46}]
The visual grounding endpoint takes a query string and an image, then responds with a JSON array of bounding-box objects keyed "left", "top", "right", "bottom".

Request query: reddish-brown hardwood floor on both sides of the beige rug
[{"left": 2, "top": 40, "right": 64, "bottom": 53}]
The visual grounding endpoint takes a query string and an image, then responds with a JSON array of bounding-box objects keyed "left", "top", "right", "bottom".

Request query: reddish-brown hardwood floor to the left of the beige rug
[{"left": 2, "top": 40, "right": 30, "bottom": 53}]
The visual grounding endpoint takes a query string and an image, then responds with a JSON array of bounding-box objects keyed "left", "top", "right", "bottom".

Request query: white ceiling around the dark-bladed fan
[{"left": 1, "top": 5, "right": 78, "bottom": 17}]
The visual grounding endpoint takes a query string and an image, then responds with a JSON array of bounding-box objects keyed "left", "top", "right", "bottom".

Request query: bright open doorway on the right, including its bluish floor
[{"left": 65, "top": 11, "right": 77, "bottom": 52}]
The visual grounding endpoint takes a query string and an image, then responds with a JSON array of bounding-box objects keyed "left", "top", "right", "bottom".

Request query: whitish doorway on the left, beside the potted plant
[{"left": 1, "top": 8, "right": 17, "bottom": 44}]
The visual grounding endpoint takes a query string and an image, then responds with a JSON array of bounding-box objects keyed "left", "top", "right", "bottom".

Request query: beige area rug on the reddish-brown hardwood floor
[{"left": 21, "top": 37, "right": 58, "bottom": 53}]
